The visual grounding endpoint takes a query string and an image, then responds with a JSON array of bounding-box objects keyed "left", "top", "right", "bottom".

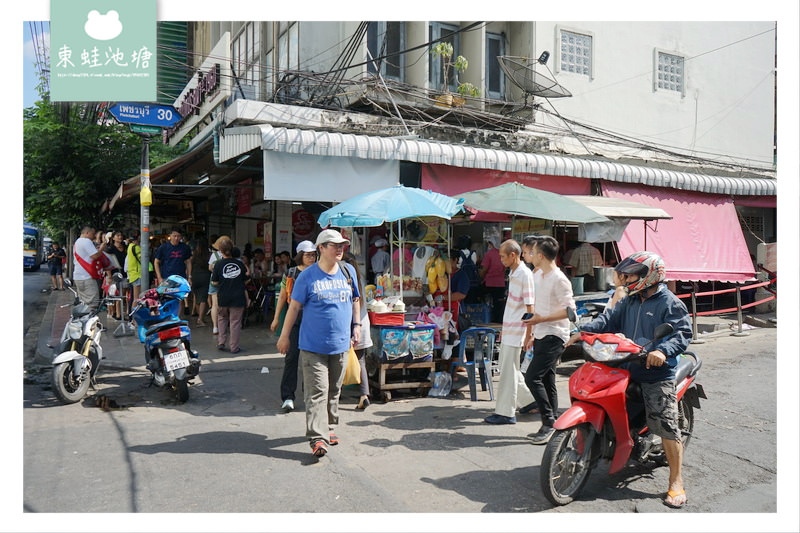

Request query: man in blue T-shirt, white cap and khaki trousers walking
[{"left": 277, "top": 229, "right": 361, "bottom": 457}]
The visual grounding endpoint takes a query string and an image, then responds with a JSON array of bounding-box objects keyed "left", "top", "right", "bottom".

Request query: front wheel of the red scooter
[{"left": 539, "top": 424, "right": 593, "bottom": 505}]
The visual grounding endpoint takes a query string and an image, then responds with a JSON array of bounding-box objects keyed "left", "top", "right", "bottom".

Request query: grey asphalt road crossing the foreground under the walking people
[{"left": 15, "top": 276, "right": 796, "bottom": 530}]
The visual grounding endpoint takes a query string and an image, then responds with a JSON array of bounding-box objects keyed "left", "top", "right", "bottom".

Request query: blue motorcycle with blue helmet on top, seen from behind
[{"left": 130, "top": 275, "right": 200, "bottom": 402}]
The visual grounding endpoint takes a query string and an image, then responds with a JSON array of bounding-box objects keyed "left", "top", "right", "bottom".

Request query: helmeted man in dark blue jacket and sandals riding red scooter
[{"left": 570, "top": 252, "right": 692, "bottom": 507}]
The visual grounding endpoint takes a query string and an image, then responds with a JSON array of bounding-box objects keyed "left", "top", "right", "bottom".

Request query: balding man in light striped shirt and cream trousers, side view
[{"left": 484, "top": 240, "right": 534, "bottom": 424}]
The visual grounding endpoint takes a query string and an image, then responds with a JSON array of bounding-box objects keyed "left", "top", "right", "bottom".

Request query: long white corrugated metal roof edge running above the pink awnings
[{"left": 220, "top": 124, "right": 777, "bottom": 196}]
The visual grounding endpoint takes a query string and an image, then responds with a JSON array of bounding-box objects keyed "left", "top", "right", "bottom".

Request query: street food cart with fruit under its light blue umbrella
[{"left": 318, "top": 185, "right": 463, "bottom": 399}]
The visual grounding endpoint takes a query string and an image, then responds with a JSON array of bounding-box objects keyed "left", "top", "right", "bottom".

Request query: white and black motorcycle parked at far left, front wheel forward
[{"left": 52, "top": 274, "right": 122, "bottom": 404}]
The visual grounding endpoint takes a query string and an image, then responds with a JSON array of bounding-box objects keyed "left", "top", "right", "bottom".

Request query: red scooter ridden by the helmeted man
[{"left": 540, "top": 309, "right": 706, "bottom": 505}]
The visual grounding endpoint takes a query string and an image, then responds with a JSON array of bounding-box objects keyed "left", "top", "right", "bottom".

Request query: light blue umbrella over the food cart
[{"left": 318, "top": 185, "right": 464, "bottom": 228}]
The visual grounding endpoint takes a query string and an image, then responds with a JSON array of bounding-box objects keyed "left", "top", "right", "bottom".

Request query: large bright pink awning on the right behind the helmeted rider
[{"left": 602, "top": 181, "right": 755, "bottom": 282}]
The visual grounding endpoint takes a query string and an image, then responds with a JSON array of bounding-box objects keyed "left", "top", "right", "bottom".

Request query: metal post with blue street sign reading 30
[{"left": 108, "top": 102, "right": 182, "bottom": 292}]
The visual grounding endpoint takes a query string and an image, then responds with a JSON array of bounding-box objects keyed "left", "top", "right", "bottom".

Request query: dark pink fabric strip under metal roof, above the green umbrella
[{"left": 420, "top": 163, "right": 592, "bottom": 196}]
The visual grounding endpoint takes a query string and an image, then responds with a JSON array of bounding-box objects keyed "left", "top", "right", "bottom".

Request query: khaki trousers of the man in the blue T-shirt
[{"left": 300, "top": 350, "right": 347, "bottom": 444}]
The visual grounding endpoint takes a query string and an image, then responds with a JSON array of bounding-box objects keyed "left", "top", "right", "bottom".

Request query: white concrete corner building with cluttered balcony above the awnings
[{"left": 106, "top": 21, "right": 777, "bottom": 288}]
